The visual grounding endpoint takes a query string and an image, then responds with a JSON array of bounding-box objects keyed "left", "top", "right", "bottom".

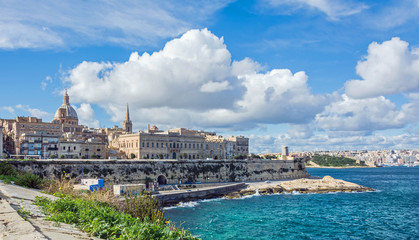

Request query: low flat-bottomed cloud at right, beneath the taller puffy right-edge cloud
[{"left": 315, "top": 95, "right": 419, "bottom": 131}]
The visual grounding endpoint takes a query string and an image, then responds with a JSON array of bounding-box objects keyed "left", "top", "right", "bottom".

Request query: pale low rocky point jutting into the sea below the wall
[{"left": 224, "top": 176, "right": 375, "bottom": 199}]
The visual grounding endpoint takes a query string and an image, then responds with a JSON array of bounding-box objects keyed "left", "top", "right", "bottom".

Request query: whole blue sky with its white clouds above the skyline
[{"left": 0, "top": 0, "right": 419, "bottom": 152}]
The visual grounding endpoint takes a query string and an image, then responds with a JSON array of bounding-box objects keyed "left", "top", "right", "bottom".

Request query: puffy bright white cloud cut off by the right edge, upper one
[{"left": 345, "top": 37, "right": 419, "bottom": 98}]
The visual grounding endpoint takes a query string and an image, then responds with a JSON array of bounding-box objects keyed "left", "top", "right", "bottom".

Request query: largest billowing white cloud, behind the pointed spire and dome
[{"left": 65, "top": 29, "right": 329, "bottom": 128}]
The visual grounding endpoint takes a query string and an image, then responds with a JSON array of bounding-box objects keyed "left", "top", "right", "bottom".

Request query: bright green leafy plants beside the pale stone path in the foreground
[{"left": 35, "top": 195, "right": 196, "bottom": 239}]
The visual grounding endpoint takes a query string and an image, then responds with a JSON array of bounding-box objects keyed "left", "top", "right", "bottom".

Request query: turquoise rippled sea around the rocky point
[{"left": 165, "top": 167, "right": 419, "bottom": 239}]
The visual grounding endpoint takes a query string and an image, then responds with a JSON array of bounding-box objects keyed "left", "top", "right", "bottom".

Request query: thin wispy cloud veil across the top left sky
[{"left": 0, "top": 0, "right": 230, "bottom": 49}]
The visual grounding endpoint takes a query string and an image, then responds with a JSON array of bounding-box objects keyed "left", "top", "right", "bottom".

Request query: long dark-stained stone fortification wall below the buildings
[{"left": 3, "top": 160, "right": 308, "bottom": 184}]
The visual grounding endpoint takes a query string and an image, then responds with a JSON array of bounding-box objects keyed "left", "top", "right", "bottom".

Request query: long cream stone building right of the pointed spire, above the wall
[{"left": 112, "top": 126, "right": 249, "bottom": 159}]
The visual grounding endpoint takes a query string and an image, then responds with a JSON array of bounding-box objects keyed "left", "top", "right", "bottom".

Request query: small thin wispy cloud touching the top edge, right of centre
[{"left": 267, "top": 0, "right": 367, "bottom": 20}]
